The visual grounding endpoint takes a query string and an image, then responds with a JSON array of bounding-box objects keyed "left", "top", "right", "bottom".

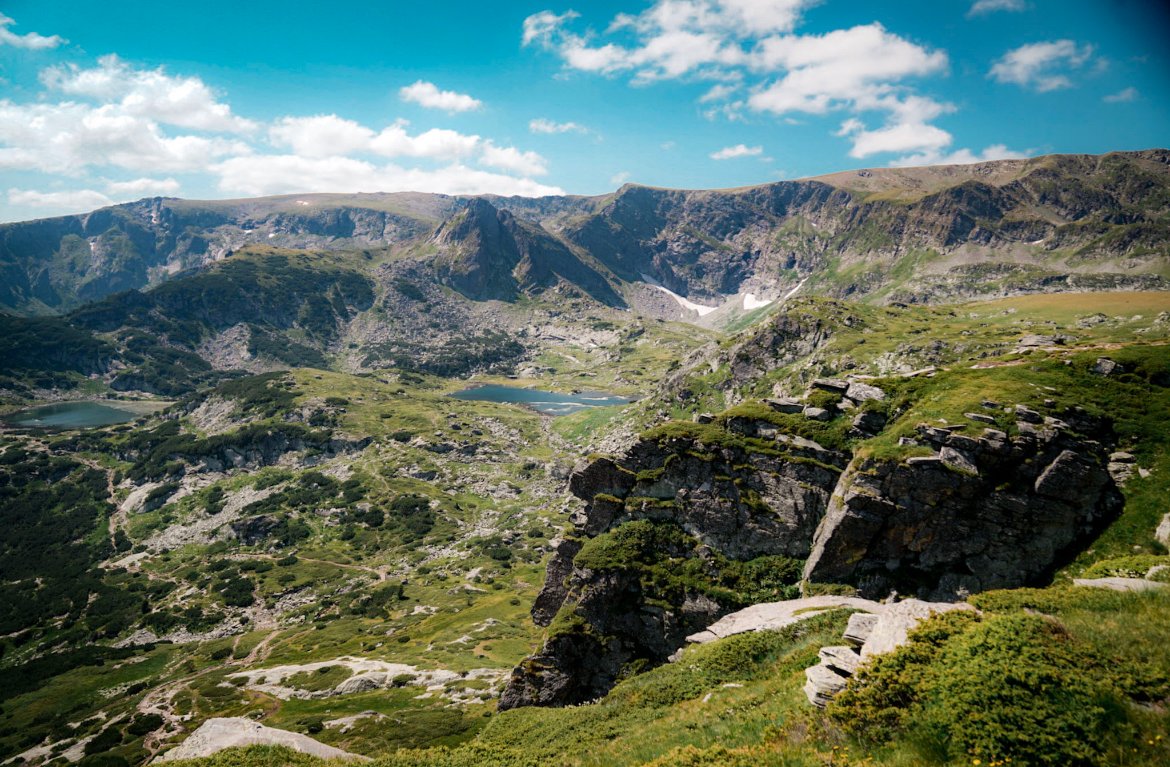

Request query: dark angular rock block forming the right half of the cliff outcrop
[{"left": 805, "top": 416, "right": 1122, "bottom": 600}]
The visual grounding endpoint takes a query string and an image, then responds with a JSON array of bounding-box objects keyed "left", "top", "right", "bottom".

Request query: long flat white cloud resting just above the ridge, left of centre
[{"left": 212, "top": 154, "right": 564, "bottom": 196}]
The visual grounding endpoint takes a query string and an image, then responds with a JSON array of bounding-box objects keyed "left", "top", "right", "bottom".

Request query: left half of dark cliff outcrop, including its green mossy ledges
[{"left": 500, "top": 419, "right": 847, "bottom": 709}]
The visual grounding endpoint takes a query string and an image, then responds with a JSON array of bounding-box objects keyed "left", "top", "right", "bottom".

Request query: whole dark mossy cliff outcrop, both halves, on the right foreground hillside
[{"left": 501, "top": 395, "right": 1122, "bottom": 709}]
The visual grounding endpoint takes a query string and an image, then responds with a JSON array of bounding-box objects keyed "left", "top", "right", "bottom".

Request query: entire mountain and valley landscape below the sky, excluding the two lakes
[{"left": 0, "top": 151, "right": 1170, "bottom": 767}]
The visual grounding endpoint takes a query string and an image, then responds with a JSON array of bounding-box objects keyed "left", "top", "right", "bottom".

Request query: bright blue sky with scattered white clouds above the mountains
[{"left": 0, "top": 0, "right": 1170, "bottom": 221}]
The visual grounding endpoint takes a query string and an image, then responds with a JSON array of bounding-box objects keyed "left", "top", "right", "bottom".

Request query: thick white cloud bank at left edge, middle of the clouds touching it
[{"left": 0, "top": 101, "right": 250, "bottom": 175}]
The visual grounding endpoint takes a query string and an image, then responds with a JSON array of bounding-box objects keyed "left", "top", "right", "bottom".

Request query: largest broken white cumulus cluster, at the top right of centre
[{"left": 522, "top": 0, "right": 954, "bottom": 157}]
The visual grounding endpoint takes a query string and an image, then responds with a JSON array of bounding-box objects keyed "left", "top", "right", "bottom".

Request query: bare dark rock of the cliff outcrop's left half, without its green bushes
[{"left": 500, "top": 419, "right": 847, "bottom": 709}]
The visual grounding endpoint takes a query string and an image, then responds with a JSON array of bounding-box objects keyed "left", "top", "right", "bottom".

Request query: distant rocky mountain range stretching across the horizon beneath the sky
[{"left": 0, "top": 150, "right": 1170, "bottom": 320}]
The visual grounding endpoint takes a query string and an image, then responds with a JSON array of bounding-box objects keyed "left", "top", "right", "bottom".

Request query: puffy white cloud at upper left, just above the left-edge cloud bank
[{"left": 41, "top": 55, "right": 256, "bottom": 133}]
